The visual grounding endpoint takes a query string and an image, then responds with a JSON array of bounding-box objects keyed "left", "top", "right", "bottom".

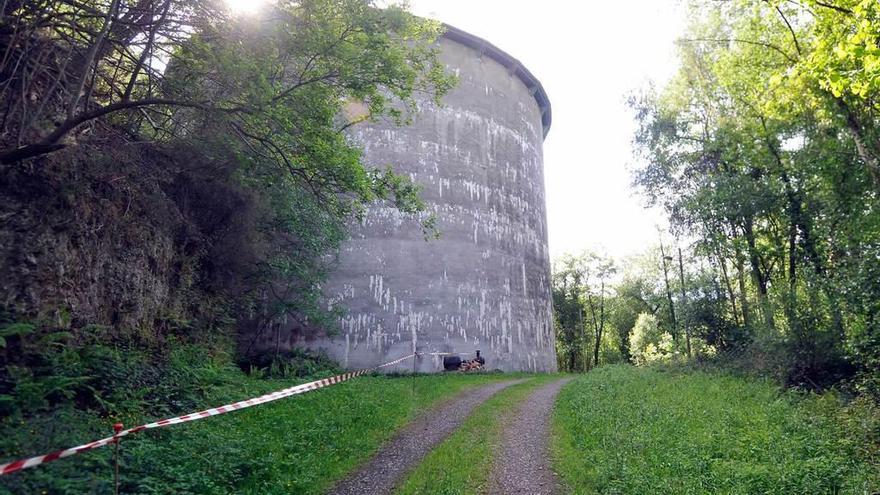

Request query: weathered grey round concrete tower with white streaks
[{"left": 282, "top": 27, "right": 556, "bottom": 372}]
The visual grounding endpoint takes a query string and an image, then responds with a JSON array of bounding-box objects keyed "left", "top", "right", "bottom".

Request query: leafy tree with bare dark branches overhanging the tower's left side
[{"left": 0, "top": 0, "right": 454, "bottom": 346}]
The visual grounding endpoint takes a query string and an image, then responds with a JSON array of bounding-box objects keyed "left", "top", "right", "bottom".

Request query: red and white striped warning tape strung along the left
[{"left": 0, "top": 354, "right": 416, "bottom": 475}]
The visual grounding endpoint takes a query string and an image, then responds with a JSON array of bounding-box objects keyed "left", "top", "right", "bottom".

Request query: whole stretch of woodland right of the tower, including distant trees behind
[{"left": 553, "top": 0, "right": 880, "bottom": 398}]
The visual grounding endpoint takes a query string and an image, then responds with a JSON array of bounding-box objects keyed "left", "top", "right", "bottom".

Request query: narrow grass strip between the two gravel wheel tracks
[{"left": 398, "top": 375, "right": 559, "bottom": 495}]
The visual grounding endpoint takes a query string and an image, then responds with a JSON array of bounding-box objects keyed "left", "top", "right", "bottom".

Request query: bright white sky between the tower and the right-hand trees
[{"left": 409, "top": 0, "right": 684, "bottom": 259}]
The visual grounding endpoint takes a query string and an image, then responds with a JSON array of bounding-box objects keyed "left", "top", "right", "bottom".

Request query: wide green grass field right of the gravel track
[{"left": 553, "top": 365, "right": 880, "bottom": 494}]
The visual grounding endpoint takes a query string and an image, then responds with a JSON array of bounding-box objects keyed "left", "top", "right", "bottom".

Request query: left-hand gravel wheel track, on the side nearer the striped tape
[{"left": 329, "top": 380, "right": 524, "bottom": 495}]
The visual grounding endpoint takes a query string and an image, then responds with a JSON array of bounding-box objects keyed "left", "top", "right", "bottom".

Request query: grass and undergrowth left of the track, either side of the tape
[{"left": 0, "top": 328, "right": 503, "bottom": 494}]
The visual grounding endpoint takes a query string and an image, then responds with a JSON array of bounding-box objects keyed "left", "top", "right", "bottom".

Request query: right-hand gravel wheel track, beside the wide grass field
[{"left": 489, "top": 378, "right": 571, "bottom": 495}]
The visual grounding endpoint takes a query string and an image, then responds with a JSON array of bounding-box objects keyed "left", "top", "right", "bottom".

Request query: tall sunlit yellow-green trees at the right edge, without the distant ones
[{"left": 632, "top": 0, "right": 880, "bottom": 393}]
